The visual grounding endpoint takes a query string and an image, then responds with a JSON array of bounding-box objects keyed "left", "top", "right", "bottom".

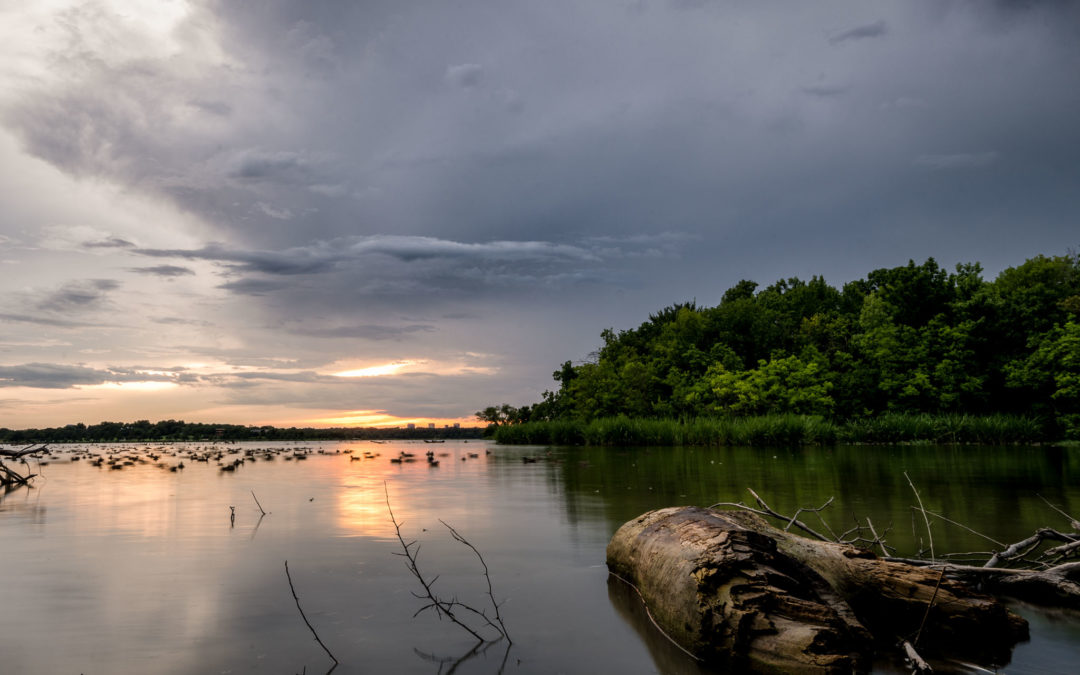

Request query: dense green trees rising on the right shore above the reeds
[{"left": 488, "top": 254, "right": 1080, "bottom": 437}]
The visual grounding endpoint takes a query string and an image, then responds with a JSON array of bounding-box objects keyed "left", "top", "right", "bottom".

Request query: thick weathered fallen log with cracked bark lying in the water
[{"left": 607, "top": 507, "right": 1027, "bottom": 673}]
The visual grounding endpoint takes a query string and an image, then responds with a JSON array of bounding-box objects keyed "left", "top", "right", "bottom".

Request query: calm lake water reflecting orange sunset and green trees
[{"left": 0, "top": 442, "right": 1080, "bottom": 675}]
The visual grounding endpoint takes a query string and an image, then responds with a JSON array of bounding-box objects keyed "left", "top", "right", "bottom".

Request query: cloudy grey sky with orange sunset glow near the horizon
[{"left": 0, "top": 0, "right": 1080, "bottom": 429}]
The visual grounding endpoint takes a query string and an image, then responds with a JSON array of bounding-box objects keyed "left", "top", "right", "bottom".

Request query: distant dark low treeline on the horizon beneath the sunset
[{"left": 0, "top": 419, "right": 482, "bottom": 444}]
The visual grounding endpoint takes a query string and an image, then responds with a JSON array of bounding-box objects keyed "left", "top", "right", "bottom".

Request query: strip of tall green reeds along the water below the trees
[{"left": 494, "top": 414, "right": 1057, "bottom": 446}]
